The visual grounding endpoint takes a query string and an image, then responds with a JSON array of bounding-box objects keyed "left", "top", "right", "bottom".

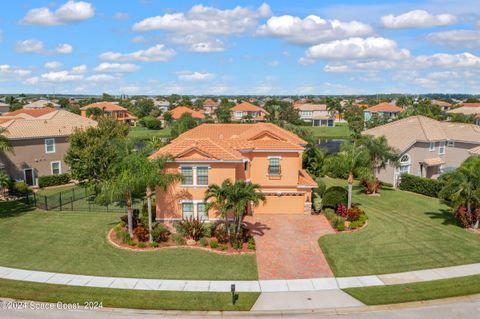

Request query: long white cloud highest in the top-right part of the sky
[{"left": 381, "top": 10, "right": 457, "bottom": 29}]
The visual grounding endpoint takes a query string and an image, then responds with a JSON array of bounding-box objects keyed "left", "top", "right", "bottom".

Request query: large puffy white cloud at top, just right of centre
[{"left": 256, "top": 15, "right": 373, "bottom": 45}]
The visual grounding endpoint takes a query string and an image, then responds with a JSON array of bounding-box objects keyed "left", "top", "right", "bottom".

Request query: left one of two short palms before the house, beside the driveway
[{"left": 204, "top": 179, "right": 233, "bottom": 238}]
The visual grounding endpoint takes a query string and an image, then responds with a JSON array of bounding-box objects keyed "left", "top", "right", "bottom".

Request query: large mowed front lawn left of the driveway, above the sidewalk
[{"left": 0, "top": 202, "right": 257, "bottom": 280}]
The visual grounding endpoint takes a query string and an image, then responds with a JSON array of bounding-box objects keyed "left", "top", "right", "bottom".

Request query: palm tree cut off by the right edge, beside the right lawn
[{"left": 439, "top": 156, "right": 480, "bottom": 229}]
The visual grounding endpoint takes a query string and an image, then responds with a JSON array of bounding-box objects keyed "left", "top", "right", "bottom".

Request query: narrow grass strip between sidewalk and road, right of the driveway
[{"left": 344, "top": 275, "right": 480, "bottom": 305}]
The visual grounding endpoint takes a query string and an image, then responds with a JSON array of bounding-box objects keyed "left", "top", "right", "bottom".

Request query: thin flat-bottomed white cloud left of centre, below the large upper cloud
[{"left": 100, "top": 44, "right": 176, "bottom": 62}]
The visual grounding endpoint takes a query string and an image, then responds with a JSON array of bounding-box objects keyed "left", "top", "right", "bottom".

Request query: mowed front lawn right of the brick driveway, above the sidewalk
[{"left": 319, "top": 178, "right": 480, "bottom": 276}]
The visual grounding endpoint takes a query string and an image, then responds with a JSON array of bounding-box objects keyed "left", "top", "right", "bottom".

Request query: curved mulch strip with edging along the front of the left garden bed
[{"left": 107, "top": 228, "right": 255, "bottom": 255}]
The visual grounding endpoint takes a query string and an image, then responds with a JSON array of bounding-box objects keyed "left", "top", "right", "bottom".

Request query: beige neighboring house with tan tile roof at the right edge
[{"left": 362, "top": 116, "right": 480, "bottom": 185}]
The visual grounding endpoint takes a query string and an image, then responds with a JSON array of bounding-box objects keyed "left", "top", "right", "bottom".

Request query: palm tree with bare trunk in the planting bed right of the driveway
[{"left": 338, "top": 141, "right": 371, "bottom": 209}]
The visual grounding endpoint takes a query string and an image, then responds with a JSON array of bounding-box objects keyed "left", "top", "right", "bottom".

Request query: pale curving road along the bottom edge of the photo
[{"left": 0, "top": 295, "right": 480, "bottom": 319}]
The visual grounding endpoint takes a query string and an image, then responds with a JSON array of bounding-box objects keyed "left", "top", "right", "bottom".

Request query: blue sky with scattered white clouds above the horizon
[{"left": 0, "top": 0, "right": 480, "bottom": 95}]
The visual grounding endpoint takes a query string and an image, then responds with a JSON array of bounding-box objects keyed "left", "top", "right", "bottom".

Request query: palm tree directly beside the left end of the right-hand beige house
[{"left": 360, "top": 136, "right": 398, "bottom": 194}]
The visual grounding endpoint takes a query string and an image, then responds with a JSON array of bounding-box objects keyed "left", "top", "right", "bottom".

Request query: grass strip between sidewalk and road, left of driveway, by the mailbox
[{"left": 0, "top": 279, "right": 259, "bottom": 311}]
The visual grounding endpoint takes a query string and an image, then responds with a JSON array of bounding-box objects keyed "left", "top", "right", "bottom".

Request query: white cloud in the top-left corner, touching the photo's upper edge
[{"left": 20, "top": 0, "right": 95, "bottom": 26}]
